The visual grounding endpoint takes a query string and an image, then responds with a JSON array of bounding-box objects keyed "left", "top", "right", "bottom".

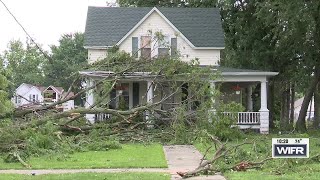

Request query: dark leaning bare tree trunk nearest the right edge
[{"left": 296, "top": 66, "right": 320, "bottom": 132}]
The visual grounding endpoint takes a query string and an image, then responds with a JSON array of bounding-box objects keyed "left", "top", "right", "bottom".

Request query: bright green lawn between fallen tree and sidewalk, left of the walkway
[{"left": 0, "top": 144, "right": 167, "bottom": 169}]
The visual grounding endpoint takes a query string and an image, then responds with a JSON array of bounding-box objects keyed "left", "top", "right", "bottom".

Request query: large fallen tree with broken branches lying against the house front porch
[{"left": 0, "top": 42, "right": 220, "bottom": 167}]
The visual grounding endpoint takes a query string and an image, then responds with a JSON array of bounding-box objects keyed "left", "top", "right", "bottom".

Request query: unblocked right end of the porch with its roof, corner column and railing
[{"left": 211, "top": 67, "right": 278, "bottom": 134}]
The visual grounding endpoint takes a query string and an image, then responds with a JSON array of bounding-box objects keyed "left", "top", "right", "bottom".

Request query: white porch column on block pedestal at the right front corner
[{"left": 259, "top": 80, "right": 269, "bottom": 134}]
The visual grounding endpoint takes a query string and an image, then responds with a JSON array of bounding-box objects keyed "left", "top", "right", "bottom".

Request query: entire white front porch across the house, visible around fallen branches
[{"left": 81, "top": 68, "right": 277, "bottom": 133}]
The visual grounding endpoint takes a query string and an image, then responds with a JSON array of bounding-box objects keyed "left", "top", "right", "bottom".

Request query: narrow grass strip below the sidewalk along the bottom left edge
[{"left": 0, "top": 173, "right": 170, "bottom": 180}]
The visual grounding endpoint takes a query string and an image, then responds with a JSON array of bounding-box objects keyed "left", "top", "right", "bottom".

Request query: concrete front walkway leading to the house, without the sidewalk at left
[{"left": 163, "top": 145, "right": 225, "bottom": 180}]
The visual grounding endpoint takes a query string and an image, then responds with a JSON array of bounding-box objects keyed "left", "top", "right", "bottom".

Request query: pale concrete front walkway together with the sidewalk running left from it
[{"left": 0, "top": 145, "right": 225, "bottom": 180}]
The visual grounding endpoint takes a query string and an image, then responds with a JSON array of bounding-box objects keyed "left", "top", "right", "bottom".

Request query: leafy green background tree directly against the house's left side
[{"left": 44, "top": 33, "right": 88, "bottom": 104}]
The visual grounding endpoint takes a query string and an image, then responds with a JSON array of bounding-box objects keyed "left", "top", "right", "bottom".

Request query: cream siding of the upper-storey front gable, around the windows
[{"left": 117, "top": 12, "right": 220, "bottom": 65}]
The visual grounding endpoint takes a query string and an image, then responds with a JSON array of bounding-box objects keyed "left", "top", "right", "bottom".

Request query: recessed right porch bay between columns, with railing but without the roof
[{"left": 214, "top": 81, "right": 268, "bottom": 130}]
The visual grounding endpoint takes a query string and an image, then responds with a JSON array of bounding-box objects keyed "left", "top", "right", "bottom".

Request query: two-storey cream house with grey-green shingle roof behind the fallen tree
[{"left": 80, "top": 7, "right": 278, "bottom": 133}]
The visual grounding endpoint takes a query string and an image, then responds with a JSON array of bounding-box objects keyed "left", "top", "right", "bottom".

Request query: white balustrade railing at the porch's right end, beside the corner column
[{"left": 222, "top": 112, "right": 260, "bottom": 124}]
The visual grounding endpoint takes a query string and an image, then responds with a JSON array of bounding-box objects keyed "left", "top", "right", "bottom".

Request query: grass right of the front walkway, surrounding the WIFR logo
[{"left": 194, "top": 133, "right": 320, "bottom": 180}]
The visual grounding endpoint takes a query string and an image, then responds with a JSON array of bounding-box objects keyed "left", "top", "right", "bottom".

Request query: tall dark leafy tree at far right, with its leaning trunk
[{"left": 258, "top": 1, "right": 320, "bottom": 131}]
